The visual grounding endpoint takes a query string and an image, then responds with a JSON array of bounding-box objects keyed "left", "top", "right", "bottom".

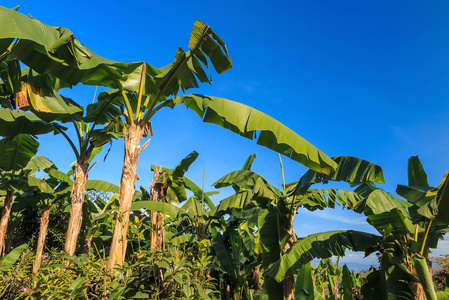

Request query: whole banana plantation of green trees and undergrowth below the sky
[{"left": 0, "top": 7, "right": 449, "bottom": 300}]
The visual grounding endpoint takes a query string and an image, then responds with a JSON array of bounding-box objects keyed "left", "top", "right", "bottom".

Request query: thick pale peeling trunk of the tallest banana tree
[{"left": 108, "top": 124, "right": 144, "bottom": 270}]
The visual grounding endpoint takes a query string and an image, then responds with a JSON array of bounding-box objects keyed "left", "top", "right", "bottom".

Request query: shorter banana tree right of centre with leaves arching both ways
[{"left": 214, "top": 156, "right": 383, "bottom": 299}]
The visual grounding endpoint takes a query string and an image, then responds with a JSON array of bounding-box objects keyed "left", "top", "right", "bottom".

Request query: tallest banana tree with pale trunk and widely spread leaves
[{"left": 0, "top": 8, "right": 336, "bottom": 268}]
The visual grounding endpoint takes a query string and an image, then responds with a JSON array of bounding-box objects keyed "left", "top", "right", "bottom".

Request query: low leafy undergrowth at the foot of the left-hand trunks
[{"left": 0, "top": 250, "right": 220, "bottom": 299}]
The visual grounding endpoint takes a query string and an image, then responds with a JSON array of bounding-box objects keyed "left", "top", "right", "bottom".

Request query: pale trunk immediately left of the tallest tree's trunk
[{"left": 64, "top": 155, "right": 90, "bottom": 256}]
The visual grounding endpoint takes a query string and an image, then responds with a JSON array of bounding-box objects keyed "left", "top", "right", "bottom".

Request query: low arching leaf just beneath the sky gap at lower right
[{"left": 265, "top": 230, "right": 380, "bottom": 282}]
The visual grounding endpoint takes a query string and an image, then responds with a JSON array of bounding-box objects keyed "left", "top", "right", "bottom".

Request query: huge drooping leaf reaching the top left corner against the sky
[{"left": 0, "top": 6, "right": 121, "bottom": 87}]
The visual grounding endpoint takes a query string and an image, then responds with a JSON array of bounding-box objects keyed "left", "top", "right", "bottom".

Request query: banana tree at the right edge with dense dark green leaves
[{"left": 356, "top": 157, "right": 449, "bottom": 299}]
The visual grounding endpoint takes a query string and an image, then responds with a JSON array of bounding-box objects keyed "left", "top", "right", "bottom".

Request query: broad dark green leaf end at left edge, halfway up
[{"left": 0, "top": 134, "right": 39, "bottom": 171}]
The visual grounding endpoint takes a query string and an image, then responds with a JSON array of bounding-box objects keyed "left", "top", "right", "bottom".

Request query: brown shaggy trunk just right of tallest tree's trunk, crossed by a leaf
[{"left": 150, "top": 169, "right": 167, "bottom": 250}]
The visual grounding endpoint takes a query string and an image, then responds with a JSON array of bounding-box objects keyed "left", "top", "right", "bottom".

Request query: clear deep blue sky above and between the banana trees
[{"left": 6, "top": 0, "right": 449, "bottom": 263}]
